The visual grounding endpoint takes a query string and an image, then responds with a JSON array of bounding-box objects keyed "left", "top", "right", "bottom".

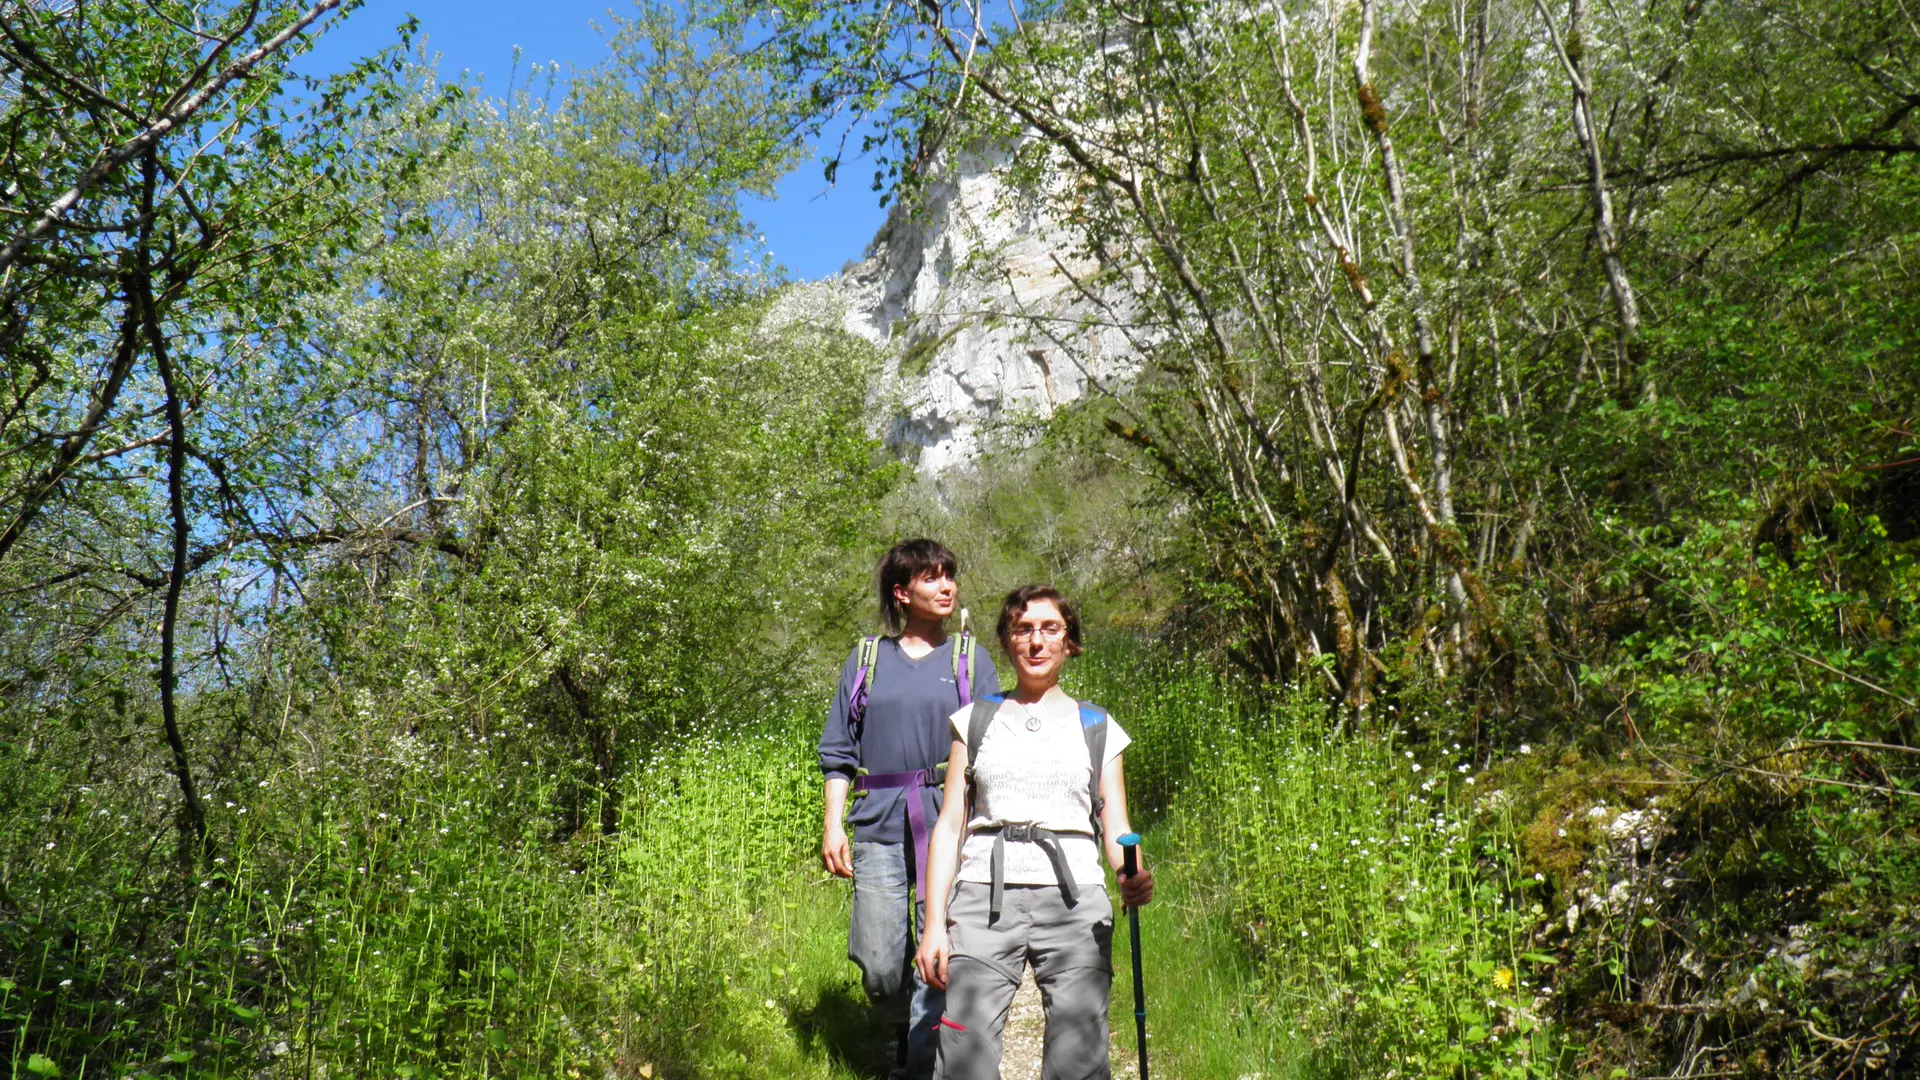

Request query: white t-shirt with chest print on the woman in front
[{"left": 952, "top": 690, "right": 1133, "bottom": 886}]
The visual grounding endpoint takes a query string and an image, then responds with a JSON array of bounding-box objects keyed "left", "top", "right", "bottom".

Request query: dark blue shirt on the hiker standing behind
[{"left": 820, "top": 636, "right": 1000, "bottom": 844}]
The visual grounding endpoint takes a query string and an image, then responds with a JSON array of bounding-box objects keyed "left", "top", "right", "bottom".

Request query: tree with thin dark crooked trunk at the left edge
[{"left": 0, "top": 0, "right": 439, "bottom": 851}]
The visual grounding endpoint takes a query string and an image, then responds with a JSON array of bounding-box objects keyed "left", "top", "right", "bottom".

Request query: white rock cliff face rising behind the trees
[{"left": 772, "top": 142, "right": 1137, "bottom": 477}]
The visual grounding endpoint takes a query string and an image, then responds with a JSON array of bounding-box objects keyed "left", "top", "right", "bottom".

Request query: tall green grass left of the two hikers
[{"left": 0, "top": 707, "right": 885, "bottom": 1078}]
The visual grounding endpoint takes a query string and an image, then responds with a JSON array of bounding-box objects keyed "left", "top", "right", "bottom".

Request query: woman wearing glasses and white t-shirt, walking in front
[{"left": 914, "top": 584, "right": 1154, "bottom": 1080}]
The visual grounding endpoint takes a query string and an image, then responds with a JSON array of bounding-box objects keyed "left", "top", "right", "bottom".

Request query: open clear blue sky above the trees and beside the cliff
[{"left": 300, "top": 0, "right": 885, "bottom": 281}]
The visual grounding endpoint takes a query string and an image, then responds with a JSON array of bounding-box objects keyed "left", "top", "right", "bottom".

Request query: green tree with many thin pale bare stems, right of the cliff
[{"left": 768, "top": 0, "right": 1920, "bottom": 722}]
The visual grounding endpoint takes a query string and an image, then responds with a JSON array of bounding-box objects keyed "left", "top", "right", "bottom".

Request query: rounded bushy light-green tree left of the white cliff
[{"left": 286, "top": 8, "right": 893, "bottom": 832}]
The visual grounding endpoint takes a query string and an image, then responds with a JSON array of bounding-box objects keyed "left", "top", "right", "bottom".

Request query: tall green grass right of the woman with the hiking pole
[{"left": 1075, "top": 645, "right": 1567, "bottom": 1078}]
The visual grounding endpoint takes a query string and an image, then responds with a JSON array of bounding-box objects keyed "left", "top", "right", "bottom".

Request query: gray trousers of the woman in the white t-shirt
[{"left": 939, "top": 882, "right": 1114, "bottom": 1080}]
